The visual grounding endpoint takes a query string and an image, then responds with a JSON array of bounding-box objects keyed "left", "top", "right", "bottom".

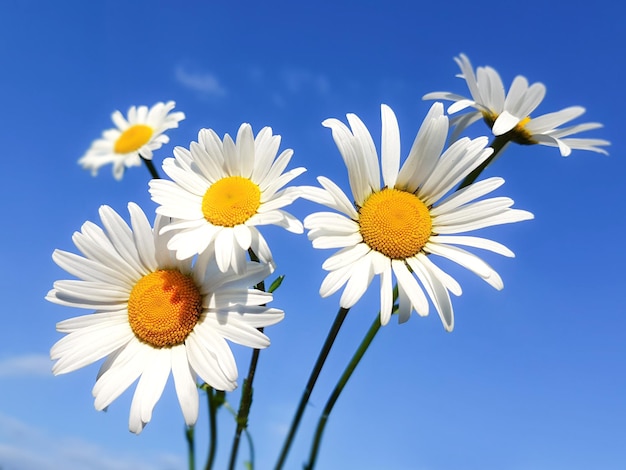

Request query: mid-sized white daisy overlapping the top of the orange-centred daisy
[{"left": 150, "top": 124, "right": 305, "bottom": 272}]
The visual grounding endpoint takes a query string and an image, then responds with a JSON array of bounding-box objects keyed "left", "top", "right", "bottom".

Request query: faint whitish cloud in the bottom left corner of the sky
[{"left": 0, "top": 414, "right": 185, "bottom": 470}]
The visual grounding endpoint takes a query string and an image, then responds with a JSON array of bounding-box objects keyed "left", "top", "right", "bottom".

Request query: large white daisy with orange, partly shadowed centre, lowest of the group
[{"left": 46, "top": 203, "right": 283, "bottom": 433}]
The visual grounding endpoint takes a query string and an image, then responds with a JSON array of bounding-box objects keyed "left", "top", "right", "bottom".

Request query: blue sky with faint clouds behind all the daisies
[{"left": 0, "top": 0, "right": 626, "bottom": 470}]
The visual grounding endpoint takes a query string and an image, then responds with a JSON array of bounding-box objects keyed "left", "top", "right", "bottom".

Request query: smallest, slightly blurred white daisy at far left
[{"left": 78, "top": 101, "right": 185, "bottom": 180}]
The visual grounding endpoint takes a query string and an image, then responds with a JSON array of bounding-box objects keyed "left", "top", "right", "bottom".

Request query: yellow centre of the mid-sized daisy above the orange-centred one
[{"left": 202, "top": 176, "right": 261, "bottom": 227}]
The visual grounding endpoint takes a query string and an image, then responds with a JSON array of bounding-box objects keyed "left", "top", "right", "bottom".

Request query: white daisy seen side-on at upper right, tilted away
[{"left": 423, "top": 54, "right": 610, "bottom": 157}]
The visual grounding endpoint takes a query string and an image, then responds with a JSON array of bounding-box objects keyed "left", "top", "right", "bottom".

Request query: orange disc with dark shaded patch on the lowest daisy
[{"left": 128, "top": 270, "right": 202, "bottom": 348}]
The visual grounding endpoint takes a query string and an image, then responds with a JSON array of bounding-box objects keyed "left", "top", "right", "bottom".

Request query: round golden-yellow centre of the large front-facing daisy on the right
[{"left": 359, "top": 188, "right": 433, "bottom": 259}]
